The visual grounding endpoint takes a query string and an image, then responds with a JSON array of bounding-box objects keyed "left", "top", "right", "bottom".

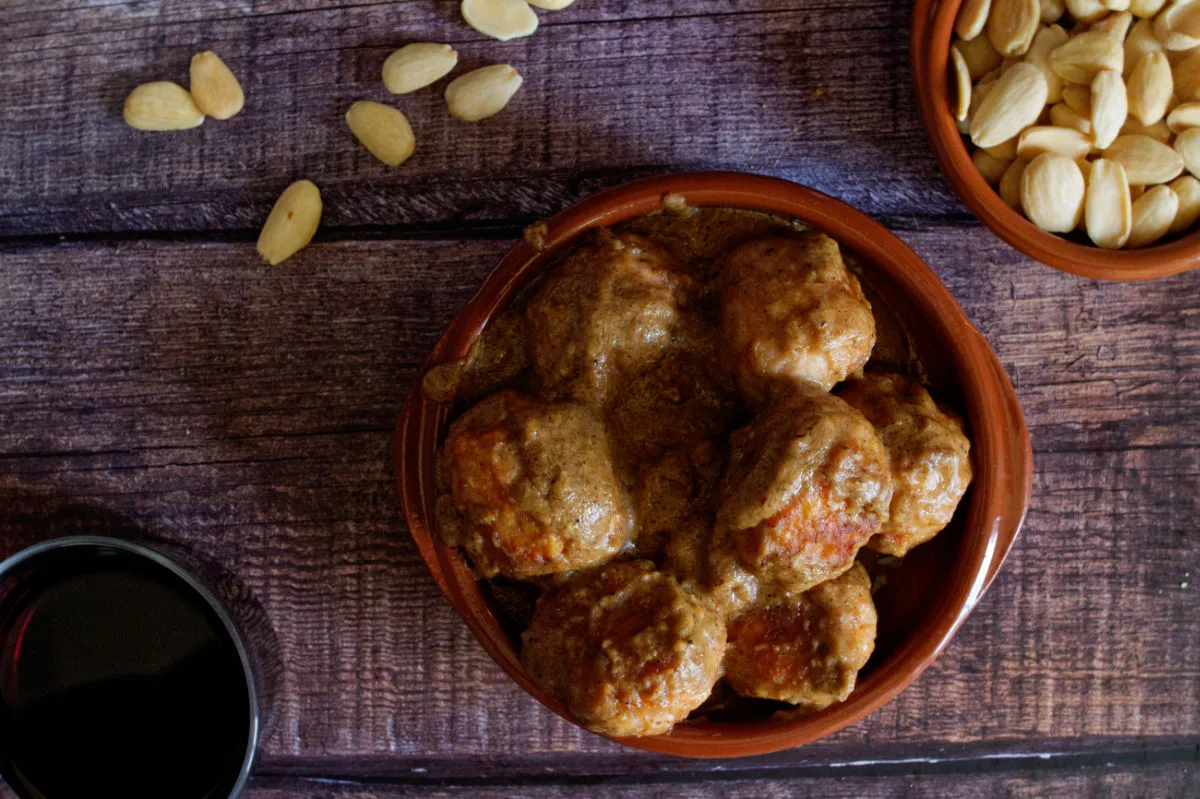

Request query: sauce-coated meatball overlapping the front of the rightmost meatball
[{"left": 716, "top": 383, "right": 892, "bottom": 591}]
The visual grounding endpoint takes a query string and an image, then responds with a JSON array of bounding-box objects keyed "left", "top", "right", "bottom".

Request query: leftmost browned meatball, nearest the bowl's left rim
[{"left": 437, "top": 391, "right": 634, "bottom": 579}]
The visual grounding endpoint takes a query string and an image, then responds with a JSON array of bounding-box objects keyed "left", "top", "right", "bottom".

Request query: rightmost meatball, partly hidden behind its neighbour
[{"left": 839, "top": 373, "right": 972, "bottom": 555}]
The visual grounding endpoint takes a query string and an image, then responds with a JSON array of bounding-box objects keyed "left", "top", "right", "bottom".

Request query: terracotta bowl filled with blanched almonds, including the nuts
[{"left": 912, "top": 0, "right": 1200, "bottom": 281}]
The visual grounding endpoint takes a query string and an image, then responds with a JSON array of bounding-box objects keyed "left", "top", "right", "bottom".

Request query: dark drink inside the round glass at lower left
[{"left": 0, "top": 549, "right": 251, "bottom": 799}]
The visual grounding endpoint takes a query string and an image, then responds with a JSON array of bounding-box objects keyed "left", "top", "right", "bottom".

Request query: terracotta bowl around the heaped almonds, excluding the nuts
[{"left": 910, "top": 0, "right": 1200, "bottom": 281}]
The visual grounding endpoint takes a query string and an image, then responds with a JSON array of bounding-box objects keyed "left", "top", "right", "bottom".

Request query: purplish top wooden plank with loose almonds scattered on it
[{"left": 0, "top": 0, "right": 962, "bottom": 238}]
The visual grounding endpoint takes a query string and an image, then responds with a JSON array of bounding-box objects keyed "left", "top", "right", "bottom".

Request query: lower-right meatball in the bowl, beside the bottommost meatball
[{"left": 725, "top": 564, "right": 878, "bottom": 710}]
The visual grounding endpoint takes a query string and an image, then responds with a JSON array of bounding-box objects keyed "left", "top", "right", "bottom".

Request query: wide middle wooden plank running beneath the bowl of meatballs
[{"left": 0, "top": 226, "right": 1200, "bottom": 774}]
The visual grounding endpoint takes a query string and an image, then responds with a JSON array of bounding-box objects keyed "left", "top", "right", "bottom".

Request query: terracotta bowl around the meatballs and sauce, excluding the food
[{"left": 395, "top": 173, "right": 1033, "bottom": 757}]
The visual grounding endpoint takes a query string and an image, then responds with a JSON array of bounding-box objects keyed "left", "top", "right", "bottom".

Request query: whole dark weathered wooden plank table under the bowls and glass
[{"left": 0, "top": 0, "right": 1200, "bottom": 799}]
